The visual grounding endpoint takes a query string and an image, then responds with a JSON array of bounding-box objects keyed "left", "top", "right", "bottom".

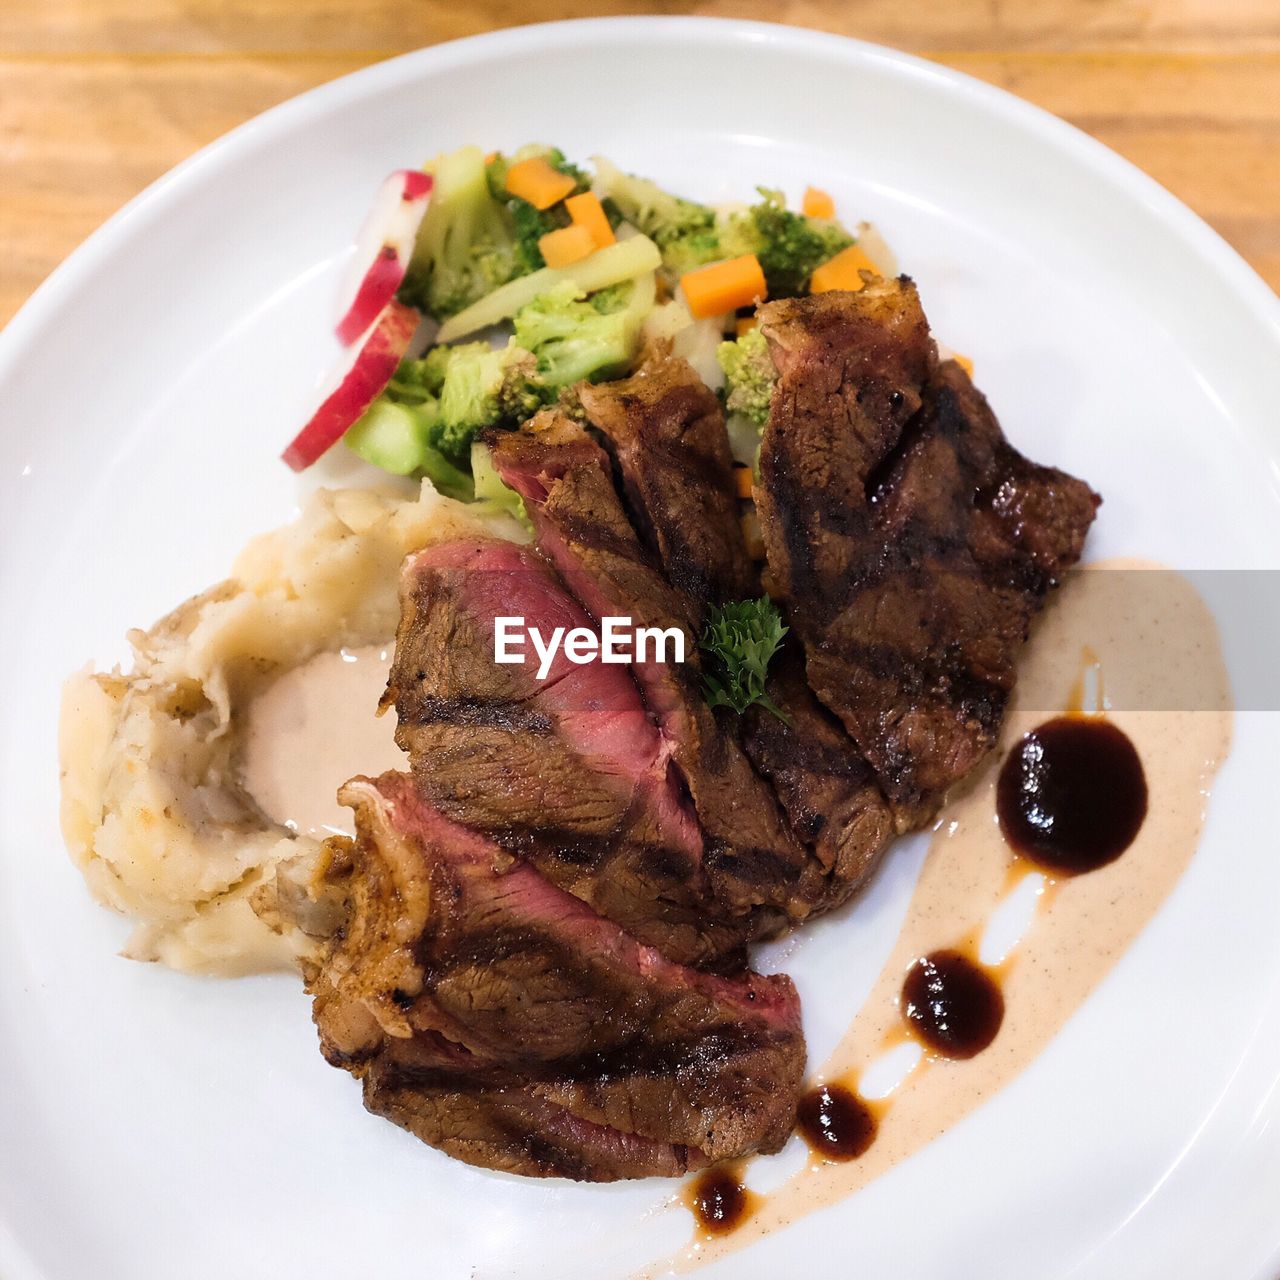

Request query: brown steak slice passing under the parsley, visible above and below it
[{"left": 580, "top": 360, "right": 893, "bottom": 911}]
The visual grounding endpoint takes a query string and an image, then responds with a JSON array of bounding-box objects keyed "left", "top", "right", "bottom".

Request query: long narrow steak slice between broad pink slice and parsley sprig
[{"left": 493, "top": 412, "right": 812, "bottom": 919}]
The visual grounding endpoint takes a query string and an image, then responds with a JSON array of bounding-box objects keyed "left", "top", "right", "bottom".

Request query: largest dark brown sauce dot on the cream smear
[{"left": 996, "top": 716, "right": 1147, "bottom": 876}]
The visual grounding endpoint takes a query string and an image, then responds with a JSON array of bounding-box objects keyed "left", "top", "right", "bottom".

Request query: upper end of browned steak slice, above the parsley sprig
[{"left": 579, "top": 357, "right": 760, "bottom": 609}]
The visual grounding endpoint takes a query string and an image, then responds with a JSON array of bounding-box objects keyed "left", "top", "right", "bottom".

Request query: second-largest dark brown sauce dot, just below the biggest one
[{"left": 902, "top": 951, "right": 1005, "bottom": 1057}]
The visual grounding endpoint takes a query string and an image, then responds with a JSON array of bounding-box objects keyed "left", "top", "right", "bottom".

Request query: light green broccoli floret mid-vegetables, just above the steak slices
[{"left": 516, "top": 280, "right": 643, "bottom": 389}]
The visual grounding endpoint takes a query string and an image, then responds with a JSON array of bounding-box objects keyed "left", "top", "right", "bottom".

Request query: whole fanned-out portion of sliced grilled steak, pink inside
[{"left": 310, "top": 279, "right": 1098, "bottom": 1180}]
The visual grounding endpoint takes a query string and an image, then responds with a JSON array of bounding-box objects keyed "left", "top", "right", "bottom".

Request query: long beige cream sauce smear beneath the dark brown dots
[{"left": 660, "top": 561, "right": 1231, "bottom": 1274}]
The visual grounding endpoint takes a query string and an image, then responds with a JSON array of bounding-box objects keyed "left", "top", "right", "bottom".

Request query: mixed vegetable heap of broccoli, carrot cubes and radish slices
[{"left": 285, "top": 146, "right": 876, "bottom": 512}]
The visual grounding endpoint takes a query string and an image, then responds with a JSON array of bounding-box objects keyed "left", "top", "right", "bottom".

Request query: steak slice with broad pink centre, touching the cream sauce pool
[{"left": 385, "top": 540, "right": 752, "bottom": 964}]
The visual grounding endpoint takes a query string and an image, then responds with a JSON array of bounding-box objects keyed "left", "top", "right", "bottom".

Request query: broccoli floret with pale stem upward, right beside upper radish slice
[{"left": 402, "top": 147, "right": 522, "bottom": 319}]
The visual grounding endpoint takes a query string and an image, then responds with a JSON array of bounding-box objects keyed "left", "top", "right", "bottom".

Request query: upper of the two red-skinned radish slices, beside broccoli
[{"left": 338, "top": 169, "right": 433, "bottom": 346}]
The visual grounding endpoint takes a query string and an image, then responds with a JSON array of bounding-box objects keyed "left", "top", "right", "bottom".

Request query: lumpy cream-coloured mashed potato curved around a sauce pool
[{"left": 59, "top": 484, "right": 521, "bottom": 974}]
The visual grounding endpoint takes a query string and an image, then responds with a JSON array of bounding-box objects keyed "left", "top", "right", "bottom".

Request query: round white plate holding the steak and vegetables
[{"left": 0, "top": 19, "right": 1280, "bottom": 1280}]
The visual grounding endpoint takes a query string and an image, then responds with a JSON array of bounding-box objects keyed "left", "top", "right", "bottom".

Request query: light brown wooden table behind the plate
[{"left": 0, "top": 0, "right": 1280, "bottom": 323}]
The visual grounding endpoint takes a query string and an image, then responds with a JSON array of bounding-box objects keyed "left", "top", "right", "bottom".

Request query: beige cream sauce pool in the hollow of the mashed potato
[{"left": 241, "top": 644, "right": 406, "bottom": 840}]
